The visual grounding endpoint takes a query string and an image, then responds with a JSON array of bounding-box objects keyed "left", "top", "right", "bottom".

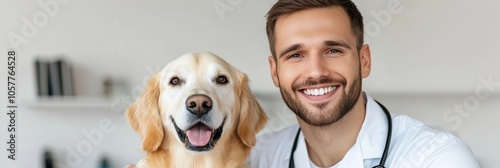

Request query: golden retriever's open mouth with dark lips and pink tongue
[{"left": 170, "top": 117, "right": 226, "bottom": 152}]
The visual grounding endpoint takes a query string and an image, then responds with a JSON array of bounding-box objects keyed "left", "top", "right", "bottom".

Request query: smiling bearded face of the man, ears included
[{"left": 269, "top": 7, "right": 371, "bottom": 126}]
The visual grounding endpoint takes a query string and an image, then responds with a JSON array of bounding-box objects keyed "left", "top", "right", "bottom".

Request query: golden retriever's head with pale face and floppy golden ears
[{"left": 126, "top": 53, "right": 267, "bottom": 152}]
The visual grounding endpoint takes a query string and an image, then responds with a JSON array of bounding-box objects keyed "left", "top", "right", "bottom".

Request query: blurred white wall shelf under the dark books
[{"left": 25, "top": 96, "right": 114, "bottom": 108}]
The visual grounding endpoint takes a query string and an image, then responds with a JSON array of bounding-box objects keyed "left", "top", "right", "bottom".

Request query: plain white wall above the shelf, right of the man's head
[{"left": 359, "top": 0, "right": 500, "bottom": 93}]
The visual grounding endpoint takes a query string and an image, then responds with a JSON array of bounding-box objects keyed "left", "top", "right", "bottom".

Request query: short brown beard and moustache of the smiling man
[{"left": 280, "top": 74, "right": 361, "bottom": 126}]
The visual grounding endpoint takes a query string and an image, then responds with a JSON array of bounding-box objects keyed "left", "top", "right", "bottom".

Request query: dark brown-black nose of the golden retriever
[{"left": 186, "top": 94, "right": 212, "bottom": 116}]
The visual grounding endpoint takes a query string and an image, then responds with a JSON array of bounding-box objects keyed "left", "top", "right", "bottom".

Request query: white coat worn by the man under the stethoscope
[{"left": 248, "top": 95, "right": 479, "bottom": 168}]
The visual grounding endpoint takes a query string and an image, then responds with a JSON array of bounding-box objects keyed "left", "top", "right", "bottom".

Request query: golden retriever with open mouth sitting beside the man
[{"left": 126, "top": 53, "right": 267, "bottom": 168}]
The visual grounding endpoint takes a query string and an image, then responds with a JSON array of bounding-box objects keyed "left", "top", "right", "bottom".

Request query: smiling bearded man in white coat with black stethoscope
[{"left": 249, "top": 0, "right": 479, "bottom": 168}]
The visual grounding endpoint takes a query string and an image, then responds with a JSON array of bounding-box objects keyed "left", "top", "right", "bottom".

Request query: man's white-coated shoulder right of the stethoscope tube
[{"left": 391, "top": 115, "right": 478, "bottom": 167}]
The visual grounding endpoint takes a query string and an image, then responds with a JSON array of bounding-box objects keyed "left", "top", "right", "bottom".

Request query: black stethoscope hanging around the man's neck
[{"left": 288, "top": 100, "right": 392, "bottom": 168}]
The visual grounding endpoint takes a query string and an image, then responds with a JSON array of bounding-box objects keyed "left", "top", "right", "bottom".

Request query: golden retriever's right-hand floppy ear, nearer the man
[{"left": 236, "top": 73, "right": 267, "bottom": 147}]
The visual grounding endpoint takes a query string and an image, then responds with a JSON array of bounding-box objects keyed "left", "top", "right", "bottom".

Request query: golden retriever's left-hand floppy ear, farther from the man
[{"left": 125, "top": 73, "right": 164, "bottom": 152}]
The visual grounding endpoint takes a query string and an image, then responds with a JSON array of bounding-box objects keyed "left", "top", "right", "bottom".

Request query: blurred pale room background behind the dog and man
[{"left": 0, "top": 0, "right": 500, "bottom": 168}]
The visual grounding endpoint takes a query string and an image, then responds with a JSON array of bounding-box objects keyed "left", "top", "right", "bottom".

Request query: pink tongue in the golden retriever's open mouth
[{"left": 186, "top": 124, "right": 212, "bottom": 146}]
